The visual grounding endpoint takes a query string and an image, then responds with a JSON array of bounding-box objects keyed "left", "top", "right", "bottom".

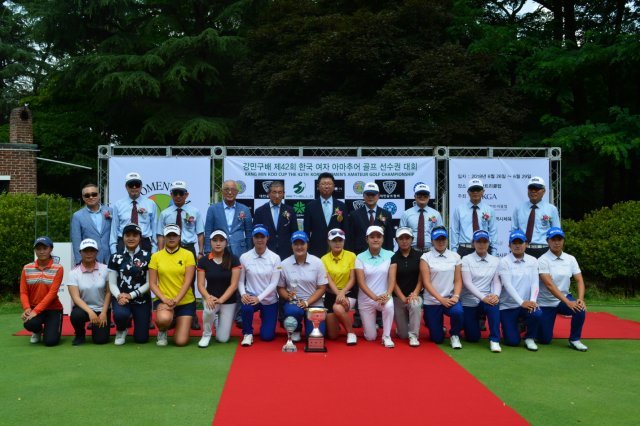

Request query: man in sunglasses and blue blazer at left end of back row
[{"left": 71, "top": 183, "right": 112, "bottom": 265}]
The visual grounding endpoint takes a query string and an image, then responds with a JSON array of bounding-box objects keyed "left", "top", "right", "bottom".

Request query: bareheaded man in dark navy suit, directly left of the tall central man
[{"left": 253, "top": 181, "right": 298, "bottom": 260}]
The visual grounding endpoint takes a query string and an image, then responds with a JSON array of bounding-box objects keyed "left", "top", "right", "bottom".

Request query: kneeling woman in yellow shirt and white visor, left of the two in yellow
[{"left": 149, "top": 225, "right": 196, "bottom": 346}]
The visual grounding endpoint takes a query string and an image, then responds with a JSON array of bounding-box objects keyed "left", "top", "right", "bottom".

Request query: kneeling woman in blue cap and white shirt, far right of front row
[{"left": 538, "top": 227, "right": 588, "bottom": 352}]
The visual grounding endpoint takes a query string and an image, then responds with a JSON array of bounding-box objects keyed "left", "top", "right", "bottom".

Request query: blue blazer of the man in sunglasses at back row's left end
[{"left": 71, "top": 205, "right": 113, "bottom": 265}]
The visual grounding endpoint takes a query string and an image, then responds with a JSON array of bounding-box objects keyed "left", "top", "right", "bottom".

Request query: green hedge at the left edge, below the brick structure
[{"left": 0, "top": 193, "right": 77, "bottom": 292}]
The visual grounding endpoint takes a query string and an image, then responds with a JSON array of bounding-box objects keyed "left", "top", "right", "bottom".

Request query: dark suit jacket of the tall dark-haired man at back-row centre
[{"left": 304, "top": 198, "right": 350, "bottom": 257}]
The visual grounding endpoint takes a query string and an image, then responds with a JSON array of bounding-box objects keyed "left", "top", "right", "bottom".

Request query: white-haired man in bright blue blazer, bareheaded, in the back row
[{"left": 204, "top": 180, "right": 253, "bottom": 257}]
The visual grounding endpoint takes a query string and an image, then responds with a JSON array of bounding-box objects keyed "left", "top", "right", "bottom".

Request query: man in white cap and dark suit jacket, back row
[{"left": 347, "top": 182, "right": 395, "bottom": 254}]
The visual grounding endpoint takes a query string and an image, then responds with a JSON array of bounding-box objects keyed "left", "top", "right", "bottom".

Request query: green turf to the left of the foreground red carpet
[{"left": 0, "top": 314, "right": 237, "bottom": 425}]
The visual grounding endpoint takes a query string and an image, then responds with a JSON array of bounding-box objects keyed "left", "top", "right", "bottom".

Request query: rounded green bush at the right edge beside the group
[{"left": 562, "top": 201, "right": 640, "bottom": 288}]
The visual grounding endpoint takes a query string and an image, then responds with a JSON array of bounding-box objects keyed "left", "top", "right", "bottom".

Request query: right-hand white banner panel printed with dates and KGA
[{"left": 449, "top": 158, "right": 550, "bottom": 256}]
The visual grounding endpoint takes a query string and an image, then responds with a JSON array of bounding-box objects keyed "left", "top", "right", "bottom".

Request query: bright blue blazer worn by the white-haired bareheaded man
[{"left": 204, "top": 201, "right": 253, "bottom": 257}]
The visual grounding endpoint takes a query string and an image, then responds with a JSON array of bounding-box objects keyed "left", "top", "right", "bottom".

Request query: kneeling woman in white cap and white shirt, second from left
[{"left": 67, "top": 238, "right": 111, "bottom": 346}]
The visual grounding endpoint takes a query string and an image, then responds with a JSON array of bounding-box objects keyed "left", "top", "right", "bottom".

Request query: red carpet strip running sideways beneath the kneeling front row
[{"left": 14, "top": 311, "right": 640, "bottom": 339}]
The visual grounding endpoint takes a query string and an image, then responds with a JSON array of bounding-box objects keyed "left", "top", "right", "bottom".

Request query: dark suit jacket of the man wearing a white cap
[{"left": 346, "top": 206, "right": 395, "bottom": 254}]
